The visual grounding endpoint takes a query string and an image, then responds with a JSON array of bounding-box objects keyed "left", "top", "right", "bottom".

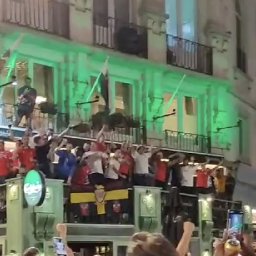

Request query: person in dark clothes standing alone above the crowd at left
[{"left": 14, "top": 77, "right": 37, "bottom": 128}]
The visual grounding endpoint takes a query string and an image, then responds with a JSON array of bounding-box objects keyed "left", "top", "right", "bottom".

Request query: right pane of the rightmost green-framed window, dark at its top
[{"left": 183, "top": 96, "right": 198, "bottom": 134}]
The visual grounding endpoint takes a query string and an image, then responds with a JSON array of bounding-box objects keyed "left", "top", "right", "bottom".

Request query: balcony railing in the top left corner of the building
[{"left": 0, "top": 0, "right": 69, "bottom": 38}]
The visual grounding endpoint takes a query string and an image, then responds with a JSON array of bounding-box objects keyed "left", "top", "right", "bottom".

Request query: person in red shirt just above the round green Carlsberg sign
[{"left": 18, "top": 136, "right": 36, "bottom": 173}]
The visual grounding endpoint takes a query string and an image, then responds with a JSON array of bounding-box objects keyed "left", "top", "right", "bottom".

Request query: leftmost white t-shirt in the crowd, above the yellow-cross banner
[{"left": 83, "top": 151, "right": 105, "bottom": 174}]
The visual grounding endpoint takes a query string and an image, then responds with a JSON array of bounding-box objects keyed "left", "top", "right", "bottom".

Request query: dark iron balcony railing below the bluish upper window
[{"left": 167, "top": 35, "right": 212, "bottom": 75}]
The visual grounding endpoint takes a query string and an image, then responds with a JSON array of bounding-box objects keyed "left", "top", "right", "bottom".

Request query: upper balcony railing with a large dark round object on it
[{"left": 93, "top": 14, "right": 147, "bottom": 58}]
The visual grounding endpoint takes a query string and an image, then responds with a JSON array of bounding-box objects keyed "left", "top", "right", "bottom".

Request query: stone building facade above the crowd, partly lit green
[{"left": 0, "top": 0, "right": 252, "bottom": 165}]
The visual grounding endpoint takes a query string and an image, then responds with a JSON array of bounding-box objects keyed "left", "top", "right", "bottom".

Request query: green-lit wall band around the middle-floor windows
[{"left": 2, "top": 34, "right": 237, "bottom": 151}]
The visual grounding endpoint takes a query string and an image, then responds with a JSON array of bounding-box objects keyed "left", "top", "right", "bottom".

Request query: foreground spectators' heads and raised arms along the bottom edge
[{"left": 20, "top": 222, "right": 255, "bottom": 256}]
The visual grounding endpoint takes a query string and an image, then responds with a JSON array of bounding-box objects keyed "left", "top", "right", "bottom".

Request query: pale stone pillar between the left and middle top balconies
[{"left": 69, "top": 0, "right": 93, "bottom": 45}]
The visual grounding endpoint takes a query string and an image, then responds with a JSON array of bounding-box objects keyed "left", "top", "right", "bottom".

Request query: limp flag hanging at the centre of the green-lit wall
[{"left": 98, "top": 58, "right": 109, "bottom": 110}]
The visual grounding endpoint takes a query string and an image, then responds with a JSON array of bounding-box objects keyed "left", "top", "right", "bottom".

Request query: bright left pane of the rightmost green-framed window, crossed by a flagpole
[{"left": 163, "top": 93, "right": 178, "bottom": 131}]
